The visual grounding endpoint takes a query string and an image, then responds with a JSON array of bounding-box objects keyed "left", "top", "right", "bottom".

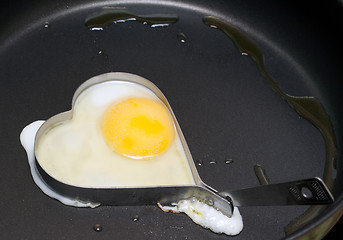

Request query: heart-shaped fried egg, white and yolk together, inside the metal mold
[{"left": 36, "top": 81, "right": 194, "bottom": 187}]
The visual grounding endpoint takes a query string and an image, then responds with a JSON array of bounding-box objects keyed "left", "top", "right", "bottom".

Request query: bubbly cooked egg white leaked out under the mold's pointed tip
[{"left": 158, "top": 200, "right": 243, "bottom": 235}]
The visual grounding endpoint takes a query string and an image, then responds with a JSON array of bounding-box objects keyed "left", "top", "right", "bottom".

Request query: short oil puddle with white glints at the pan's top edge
[{"left": 85, "top": 7, "right": 179, "bottom": 31}]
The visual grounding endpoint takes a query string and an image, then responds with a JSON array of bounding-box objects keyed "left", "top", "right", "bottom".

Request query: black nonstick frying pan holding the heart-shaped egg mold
[{"left": 0, "top": 0, "right": 343, "bottom": 239}]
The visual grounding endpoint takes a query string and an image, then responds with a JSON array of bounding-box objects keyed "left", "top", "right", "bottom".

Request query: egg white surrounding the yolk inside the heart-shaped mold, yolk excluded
[{"left": 36, "top": 81, "right": 194, "bottom": 187}]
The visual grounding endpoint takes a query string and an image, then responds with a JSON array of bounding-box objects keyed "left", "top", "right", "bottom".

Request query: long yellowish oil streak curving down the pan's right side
[{"left": 203, "top": 16, "right": 337, "bottom": 235}]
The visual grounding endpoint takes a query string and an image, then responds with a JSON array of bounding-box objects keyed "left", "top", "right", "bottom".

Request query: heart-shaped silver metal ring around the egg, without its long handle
[{"left": 35, "top": 72, "right": 233, "bottom": 216}]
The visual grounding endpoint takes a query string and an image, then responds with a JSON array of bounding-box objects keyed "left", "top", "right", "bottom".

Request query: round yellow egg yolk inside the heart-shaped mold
[{"left": 102, "top": 98, "right": 174, "bottom": 159}]
